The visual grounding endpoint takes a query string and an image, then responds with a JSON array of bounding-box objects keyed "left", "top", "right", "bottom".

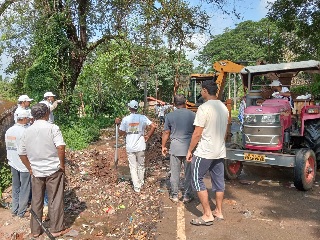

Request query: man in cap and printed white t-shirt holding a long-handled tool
[{"left": 115, "top": 100, "right": 156, "bottom": 192}]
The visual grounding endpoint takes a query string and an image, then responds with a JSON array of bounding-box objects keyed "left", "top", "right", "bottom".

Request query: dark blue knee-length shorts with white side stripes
[{"left": 191, "top": 156, "right": 225, "bottom": 192}]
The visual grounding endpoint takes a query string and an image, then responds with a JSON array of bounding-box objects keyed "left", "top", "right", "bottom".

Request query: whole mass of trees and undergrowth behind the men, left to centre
[{"left": 0, "top": 0, "right": 204, "bottom": 149}]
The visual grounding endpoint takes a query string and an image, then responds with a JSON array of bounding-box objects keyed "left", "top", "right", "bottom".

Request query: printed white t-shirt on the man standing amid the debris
[{"left": 119, "top": 113, "right": 152, "bottom": 152}]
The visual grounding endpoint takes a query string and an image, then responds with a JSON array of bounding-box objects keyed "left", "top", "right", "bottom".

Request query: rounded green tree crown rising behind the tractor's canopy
[{"left": 199, "top": 19, "right": 282, "bottom": 66}]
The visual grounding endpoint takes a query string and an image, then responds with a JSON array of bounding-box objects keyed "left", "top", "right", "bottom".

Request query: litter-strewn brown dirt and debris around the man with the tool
[{"left": 0, "top": 127, "right": 168, "bottom": 239}]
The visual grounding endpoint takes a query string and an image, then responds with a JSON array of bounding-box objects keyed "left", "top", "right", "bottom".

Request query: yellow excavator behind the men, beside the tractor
[{"left": 186, "top": 60, "right": 244, "bottom": 141}]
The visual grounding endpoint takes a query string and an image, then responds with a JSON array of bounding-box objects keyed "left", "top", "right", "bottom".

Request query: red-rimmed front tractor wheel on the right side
[{"left": 294, "top": 148, "right": 317, "bottom": 191}]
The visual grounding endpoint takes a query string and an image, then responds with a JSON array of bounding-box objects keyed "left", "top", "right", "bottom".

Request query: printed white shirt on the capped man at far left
[{"left": 5, "top": 123, "right": 29, "bottom": 172}]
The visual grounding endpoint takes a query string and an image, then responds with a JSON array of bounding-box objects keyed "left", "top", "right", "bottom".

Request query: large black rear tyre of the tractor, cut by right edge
[{"left": 304, "top": 119, "right": 320, "bottom": 168}]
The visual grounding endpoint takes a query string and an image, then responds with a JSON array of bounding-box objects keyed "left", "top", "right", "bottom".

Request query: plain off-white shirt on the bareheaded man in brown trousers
[{"left": 18, "top": 120, "right": 66, "bottom": 177}]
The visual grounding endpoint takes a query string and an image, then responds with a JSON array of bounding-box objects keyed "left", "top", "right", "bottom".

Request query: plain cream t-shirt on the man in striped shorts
[{"left": 194, "top": 100, "right": 229, "bottom": 159}]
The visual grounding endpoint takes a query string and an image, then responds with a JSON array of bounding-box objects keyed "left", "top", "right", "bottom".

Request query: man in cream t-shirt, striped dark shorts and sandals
[{"left": 186, "top": 80, "right": 229, "bottom": 226}]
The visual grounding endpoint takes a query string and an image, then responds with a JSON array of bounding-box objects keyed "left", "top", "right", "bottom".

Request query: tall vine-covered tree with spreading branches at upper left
[{"left": 1, "top": 0, "right": 207, "bottom": 107}]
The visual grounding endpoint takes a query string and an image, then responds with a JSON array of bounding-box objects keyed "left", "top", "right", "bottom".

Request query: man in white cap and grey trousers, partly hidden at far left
[{"left": 5, "top": 110, "right": 31, "bottom": 217}]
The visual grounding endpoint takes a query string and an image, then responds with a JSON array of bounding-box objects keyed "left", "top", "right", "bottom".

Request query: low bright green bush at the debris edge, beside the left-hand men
[{"left": 58, "top": 116, "right": 114, "bottom": 150}]
